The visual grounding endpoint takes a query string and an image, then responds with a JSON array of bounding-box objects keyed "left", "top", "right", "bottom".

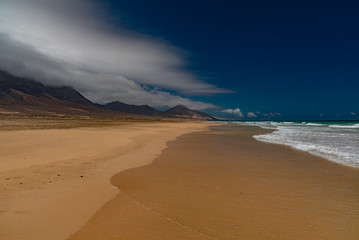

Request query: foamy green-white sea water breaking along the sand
[{"left": 237, "top": 121, "right": 359, "bottom": 168}]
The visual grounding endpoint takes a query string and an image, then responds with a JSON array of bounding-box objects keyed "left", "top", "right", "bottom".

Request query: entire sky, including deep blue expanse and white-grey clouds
[{"left": 0, "top": 0, "right": 359, "bottom": 120}]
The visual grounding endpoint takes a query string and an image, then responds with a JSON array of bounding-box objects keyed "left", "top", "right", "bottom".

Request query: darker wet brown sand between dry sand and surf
[{"left": 70, "top": 127, "right": 359, "bottom": 240}]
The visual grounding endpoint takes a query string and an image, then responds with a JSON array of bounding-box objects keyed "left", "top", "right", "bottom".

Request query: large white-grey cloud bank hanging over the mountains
[{"left": 0, "top": 0, "right": 229, "bottom": 109}]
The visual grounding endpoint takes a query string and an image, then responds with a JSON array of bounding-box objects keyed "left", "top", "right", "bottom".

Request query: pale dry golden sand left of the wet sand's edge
[{"left": 0, "top": 122, "right": 208, "bottom": 240}]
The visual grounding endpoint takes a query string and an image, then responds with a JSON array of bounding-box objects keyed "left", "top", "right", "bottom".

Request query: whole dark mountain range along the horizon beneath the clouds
[{"left": 0, "top": 70, "right": 218, "bottom": 120}]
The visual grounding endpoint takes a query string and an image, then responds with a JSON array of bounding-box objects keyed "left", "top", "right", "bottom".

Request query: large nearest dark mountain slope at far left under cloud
[{"left": 0, "top": 71, "right": 121, "bottom": 117}]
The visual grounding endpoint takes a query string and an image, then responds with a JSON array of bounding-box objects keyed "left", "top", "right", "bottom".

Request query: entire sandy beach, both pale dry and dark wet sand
[{"left": 0, "top": 122, "right": 359, "bottom": 240}]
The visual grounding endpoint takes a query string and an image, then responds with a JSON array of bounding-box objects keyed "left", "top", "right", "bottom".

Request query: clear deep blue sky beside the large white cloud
[{"left": 100, "top": 0, "right": 359, "bottom": 118}]
